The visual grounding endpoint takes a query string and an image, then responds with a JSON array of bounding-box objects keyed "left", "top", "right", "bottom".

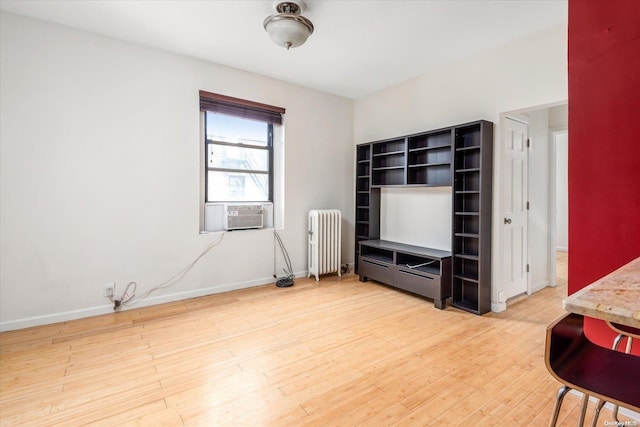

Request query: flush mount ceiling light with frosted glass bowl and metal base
[{"left": 264, "top": 0, "right": 313, "bottom": 50}]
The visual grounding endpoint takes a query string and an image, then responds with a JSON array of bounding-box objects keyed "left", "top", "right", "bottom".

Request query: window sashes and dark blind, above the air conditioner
[{"left": 200, "top": 91, "right": 284, "bottom": 203}]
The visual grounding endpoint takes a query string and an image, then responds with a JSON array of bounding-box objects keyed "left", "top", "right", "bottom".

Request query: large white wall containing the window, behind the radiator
[{"left": 0, "top": 14, "right": 354, "bottom": 330}]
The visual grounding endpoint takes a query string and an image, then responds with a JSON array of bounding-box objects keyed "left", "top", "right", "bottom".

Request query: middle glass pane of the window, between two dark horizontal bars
[{"left": 207, "top": 144, "right": 269, "bottom": 172}]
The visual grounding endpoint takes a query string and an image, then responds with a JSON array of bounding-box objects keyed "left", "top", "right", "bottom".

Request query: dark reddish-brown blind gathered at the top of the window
[{"left": 200, "top": 90, "right": 285, "bottom": 124}]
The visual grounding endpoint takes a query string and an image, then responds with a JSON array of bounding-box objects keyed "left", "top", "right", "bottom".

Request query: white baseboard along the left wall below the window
[{"left": 0, "top": 270, "right": 307, "bottom": 332}]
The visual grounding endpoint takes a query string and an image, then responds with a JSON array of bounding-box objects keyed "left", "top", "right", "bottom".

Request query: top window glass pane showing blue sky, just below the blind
[{"left": 206, "top": 112, "right": 269, "bottom": 147}]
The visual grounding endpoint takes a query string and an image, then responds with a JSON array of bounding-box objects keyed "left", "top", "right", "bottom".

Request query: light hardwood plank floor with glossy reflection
[{"left": 0, "top": 252, "right": 636, "bottom": 427}]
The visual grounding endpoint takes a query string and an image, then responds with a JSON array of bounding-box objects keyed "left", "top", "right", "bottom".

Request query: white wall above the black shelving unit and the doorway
[{"left": 354, "top": 25, "right": 567, "bottom": 310}]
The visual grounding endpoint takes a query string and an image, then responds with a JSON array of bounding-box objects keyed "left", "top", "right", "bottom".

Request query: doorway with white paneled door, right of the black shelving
[{"left": 493, "top": 102, "right": 568, "bottom": 311}]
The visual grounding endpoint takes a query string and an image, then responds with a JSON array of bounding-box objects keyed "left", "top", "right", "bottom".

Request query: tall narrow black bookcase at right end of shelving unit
[{"left": 451, "top": 121, "right": 493, "bottom": 314}]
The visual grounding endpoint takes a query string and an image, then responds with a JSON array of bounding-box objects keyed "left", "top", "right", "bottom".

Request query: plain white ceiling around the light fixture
[{"left": 0, "top": 0, "right": 567, "bottom": 99}]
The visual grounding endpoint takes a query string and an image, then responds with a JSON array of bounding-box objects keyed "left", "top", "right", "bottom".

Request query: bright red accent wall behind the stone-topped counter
[{"left": 568, "top": 0, "right": 640, "bottom": 354}]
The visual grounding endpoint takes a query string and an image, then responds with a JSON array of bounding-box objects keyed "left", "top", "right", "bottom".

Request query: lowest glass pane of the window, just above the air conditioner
[{"left": 207, "top": 171, "right": 269, "bottom": 202}]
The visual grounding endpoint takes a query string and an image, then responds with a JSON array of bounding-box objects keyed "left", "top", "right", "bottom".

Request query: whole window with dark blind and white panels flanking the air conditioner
[{"left": 200, "top": 91, "right": 285, "bottom": 232}]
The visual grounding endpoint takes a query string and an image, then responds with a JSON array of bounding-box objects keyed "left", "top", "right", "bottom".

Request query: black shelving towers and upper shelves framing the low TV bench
[{"left": 355, "top": 120, "right": 493, "bottom": 314}]
